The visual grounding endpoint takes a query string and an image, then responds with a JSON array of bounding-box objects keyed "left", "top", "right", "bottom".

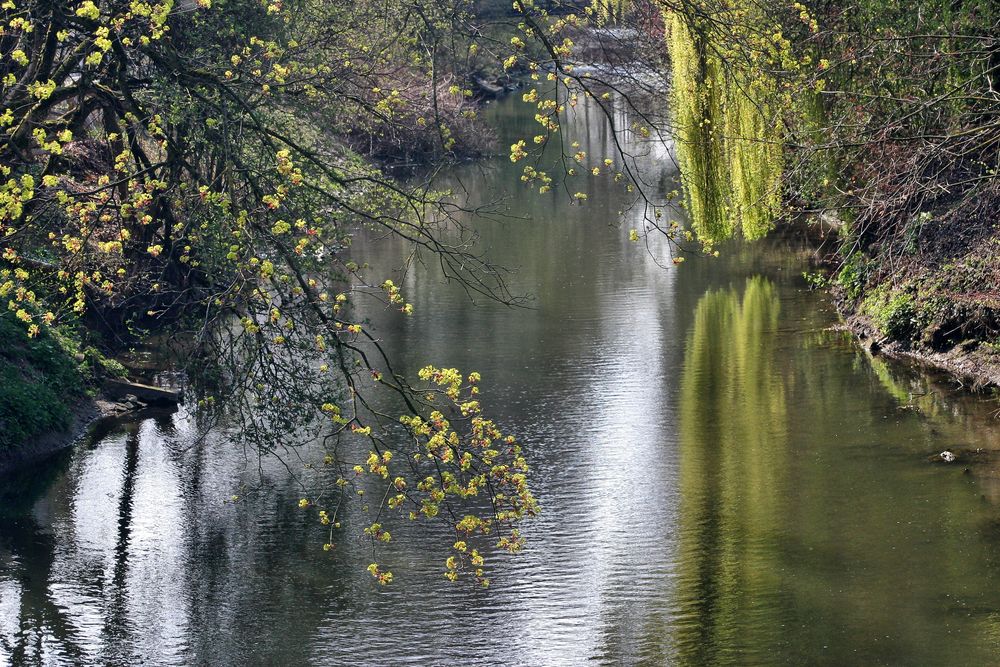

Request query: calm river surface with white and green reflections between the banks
[{"left": 0, "top": 90, "right": 1000, "bottom": 665}]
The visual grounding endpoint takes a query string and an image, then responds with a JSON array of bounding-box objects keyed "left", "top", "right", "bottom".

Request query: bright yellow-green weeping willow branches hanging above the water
[{"left": 664, "top": 11, "right": 782, "bottom": 241}]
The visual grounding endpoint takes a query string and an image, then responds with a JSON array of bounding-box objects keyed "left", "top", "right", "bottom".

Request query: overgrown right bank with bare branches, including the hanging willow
[{"left": 665, "top": 0, "right": 1000, "bottom": 368}]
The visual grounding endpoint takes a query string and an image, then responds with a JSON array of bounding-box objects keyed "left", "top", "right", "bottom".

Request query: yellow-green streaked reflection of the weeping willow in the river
[{"left": 676, "top": 277, "right": 787, "bottom": 664}]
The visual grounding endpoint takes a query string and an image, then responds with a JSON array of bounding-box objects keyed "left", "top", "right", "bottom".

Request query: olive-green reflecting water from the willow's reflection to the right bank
[{"left": 676, "top": 277, "right": 1000, "bottom": 665}]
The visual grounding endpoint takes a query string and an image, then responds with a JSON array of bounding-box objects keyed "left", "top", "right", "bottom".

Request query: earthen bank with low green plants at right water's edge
[{"left": 833, "top": 197, "right": 1000, "bottom": 390}]
